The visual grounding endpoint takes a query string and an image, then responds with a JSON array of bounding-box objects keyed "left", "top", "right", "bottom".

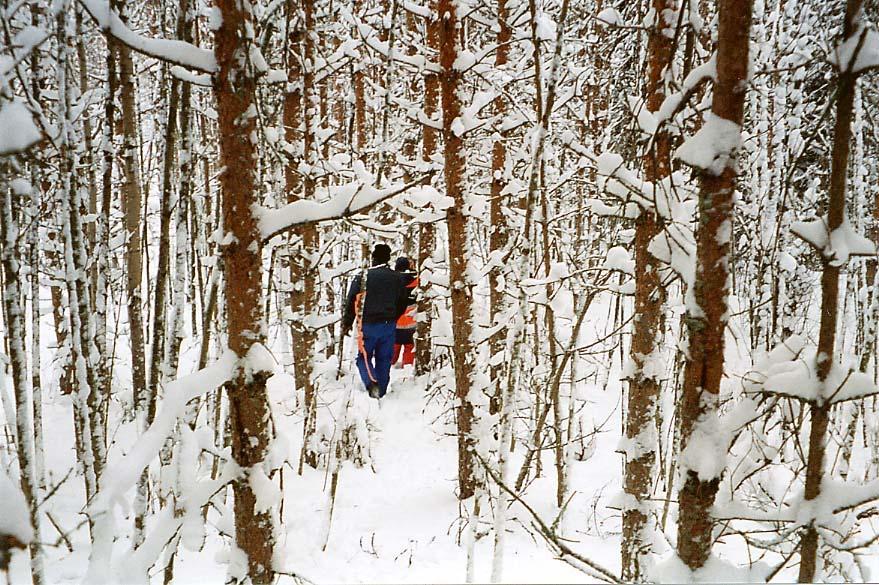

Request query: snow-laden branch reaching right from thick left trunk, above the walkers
[{"left": 253, "top": 172, "right": 443, "bottom": 241}]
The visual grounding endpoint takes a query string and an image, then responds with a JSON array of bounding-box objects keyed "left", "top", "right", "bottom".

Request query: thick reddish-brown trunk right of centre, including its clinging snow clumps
[{"left": 677, "top": 0, "right": 752, "bottom": 570}]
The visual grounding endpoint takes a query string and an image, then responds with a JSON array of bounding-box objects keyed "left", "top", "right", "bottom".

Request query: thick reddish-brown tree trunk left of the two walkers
[{"left": 213, "top": 0, "right": 275, "bottom": 584}]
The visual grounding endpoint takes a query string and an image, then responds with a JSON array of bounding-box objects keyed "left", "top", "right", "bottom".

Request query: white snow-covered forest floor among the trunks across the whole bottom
[{"left": 10, "top": 295, "right": 879, "bottom": 583}]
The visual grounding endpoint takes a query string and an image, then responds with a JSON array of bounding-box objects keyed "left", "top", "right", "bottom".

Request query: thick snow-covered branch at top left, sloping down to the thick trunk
[{"left": 78, "top": 0, "right": 217, "bottom": 73}]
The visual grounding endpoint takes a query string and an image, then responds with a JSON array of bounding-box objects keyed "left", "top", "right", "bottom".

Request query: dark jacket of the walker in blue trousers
[{"left": 342, "top": 264, "right": 409, "bottom": 331}]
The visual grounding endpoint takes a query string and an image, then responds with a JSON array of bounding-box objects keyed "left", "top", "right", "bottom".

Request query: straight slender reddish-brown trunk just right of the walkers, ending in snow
[{"left": 439, "top": 0, "right": 476, "bottom": 500}]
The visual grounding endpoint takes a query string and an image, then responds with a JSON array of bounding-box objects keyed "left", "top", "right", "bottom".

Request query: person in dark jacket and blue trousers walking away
[{"left": 342, "top": 244, "right": 408, "bottom": 398}]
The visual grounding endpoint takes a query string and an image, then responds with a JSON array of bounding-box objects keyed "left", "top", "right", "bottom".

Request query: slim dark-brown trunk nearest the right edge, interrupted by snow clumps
[{"left": 799, "top": 0, "right": 862, "bottom": 583}]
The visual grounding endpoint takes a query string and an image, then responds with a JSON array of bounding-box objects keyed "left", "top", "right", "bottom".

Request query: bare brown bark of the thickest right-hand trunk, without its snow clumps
[{"left": 678, "top": 0, "right": 752, "bottom": 570}]
